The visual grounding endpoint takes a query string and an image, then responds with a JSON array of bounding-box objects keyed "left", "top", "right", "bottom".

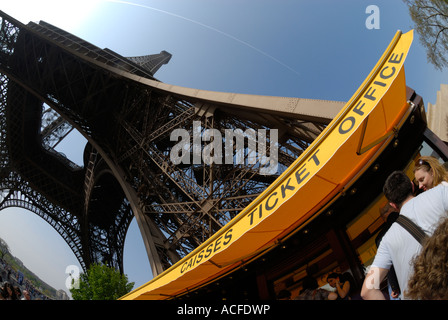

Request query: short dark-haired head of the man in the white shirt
[{"left": 383, "top": 171, "right": 414, "bottom": 210}]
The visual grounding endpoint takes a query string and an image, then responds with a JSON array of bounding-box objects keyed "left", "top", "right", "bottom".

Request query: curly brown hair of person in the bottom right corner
[{"left": 406, "top": 218, "right": 448, "bottom": 300}]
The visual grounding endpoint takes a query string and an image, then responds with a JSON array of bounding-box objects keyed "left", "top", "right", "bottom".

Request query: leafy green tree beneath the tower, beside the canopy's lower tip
[{"left": 70, "top": 264, "right": 134, "bottom": 300}]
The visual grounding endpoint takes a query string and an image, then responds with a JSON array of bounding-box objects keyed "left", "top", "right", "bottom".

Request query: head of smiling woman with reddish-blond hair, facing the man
[{"left": 414, "top": 156, "right": 448, "bottom": 191}]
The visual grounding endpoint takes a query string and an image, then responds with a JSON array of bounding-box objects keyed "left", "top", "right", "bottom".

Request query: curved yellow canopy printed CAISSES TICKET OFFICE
[{"left": 121, "top": 31, "right": 413, "bottom": 300}]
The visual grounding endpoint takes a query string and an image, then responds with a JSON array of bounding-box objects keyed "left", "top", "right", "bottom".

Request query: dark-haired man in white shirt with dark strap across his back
[{"left": 361, "top": 171, "right": 448, "bottom": 300}]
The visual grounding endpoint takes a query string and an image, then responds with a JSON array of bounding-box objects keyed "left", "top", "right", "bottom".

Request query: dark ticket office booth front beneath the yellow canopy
[{"left": 170, "top": 91, "right": 448, "bottom": 301}]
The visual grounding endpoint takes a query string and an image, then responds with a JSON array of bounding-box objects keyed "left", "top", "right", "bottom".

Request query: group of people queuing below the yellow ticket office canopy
[{"left": 277, "top": 156, "right": 448, "bottom": 300}]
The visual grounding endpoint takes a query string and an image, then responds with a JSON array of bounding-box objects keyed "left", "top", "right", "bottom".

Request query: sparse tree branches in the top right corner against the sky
[{"left": 403, "top": 0, "right": 448, "bottom": 70}]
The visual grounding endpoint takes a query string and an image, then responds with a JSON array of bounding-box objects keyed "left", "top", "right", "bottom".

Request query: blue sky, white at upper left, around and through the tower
[{"left": 0, "top": 0, "right": 448, "bottom": 291}]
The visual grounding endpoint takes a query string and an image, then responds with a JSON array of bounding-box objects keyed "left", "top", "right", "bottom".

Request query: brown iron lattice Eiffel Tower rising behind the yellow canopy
[{"left": 0, "top": 12, "right": 344, "bottom": 276}]
